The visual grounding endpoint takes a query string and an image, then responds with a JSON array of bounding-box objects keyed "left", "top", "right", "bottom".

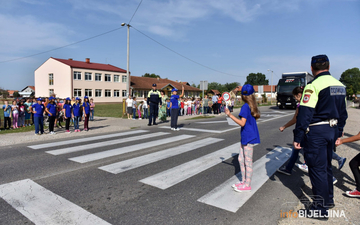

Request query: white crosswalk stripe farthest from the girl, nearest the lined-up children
[{"left": 28, "top": 130, "right": 149, "bottom": 149}]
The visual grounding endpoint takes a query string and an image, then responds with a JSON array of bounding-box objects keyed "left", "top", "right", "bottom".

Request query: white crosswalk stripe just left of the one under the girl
[{"left": 140, "top": 143, "right": 240, "bottom": 190}]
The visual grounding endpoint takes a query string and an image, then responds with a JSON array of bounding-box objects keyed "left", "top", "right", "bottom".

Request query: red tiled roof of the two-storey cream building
[{"left": 51, "top": 57, "right": 126, "bottom": 73}]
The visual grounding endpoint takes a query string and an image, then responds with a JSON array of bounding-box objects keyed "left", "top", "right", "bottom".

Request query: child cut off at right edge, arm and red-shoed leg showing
[{"left": 335, "top": 132, "right": 360, "bottom": 198}]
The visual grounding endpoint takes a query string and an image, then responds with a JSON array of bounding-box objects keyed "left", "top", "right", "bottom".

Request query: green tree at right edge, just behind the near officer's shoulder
[{"left": 340, "top": 67, "right": 360, "bottom": 96}]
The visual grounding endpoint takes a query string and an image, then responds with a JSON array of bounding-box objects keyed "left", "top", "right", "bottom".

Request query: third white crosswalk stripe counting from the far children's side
[{"left": 69, "top": 134, "right": 195, "bottom": 163}]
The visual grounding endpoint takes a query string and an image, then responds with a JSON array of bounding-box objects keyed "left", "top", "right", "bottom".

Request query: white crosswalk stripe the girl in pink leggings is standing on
[{"left": 198, "top": 147, "right": 291, "bottom": 213}]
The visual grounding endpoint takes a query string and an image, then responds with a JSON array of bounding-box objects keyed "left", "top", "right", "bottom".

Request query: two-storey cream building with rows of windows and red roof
[{"left": 35, "top": 57, "right": 127, "bottom": 102}]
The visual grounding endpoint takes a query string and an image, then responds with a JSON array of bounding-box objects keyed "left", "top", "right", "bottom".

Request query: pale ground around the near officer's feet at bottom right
[{"left": 278, "top": 107, "right": 360, "bottom": 225}]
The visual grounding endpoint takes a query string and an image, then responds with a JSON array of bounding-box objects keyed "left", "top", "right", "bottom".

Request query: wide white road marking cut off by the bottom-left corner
[{"left": 0, "top": 179, "right": 110, "bottom": 225}]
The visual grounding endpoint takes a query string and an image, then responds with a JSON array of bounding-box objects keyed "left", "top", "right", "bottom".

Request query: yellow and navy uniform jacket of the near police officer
[{"left": 294, "top": 72, "right": 348, "bottom": 143}]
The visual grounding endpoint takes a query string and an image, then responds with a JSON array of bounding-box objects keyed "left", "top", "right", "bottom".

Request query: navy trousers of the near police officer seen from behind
[{"left": 303, "top": 124, "right": 338, "bottom": 215}]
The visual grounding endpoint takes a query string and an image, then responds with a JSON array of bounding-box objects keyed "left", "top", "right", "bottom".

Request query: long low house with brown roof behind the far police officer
[{"left": 130, "top": 76, "right": 202, "bottom": 100}]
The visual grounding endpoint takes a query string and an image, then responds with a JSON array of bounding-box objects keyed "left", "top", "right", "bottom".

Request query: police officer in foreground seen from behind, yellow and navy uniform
[{"left": 293, "top": 55, "right": 347, "bottom": 219}]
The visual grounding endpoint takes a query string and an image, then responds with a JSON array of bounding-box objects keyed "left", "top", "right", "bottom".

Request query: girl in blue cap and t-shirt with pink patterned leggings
[{"left": 225, "top": 84, "right": 260, "bottom": 192}]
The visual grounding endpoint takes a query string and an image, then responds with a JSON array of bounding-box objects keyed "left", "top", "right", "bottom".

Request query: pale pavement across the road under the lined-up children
[{"left": 0, "top": 108, "right": 236, "bottom": 146}]
